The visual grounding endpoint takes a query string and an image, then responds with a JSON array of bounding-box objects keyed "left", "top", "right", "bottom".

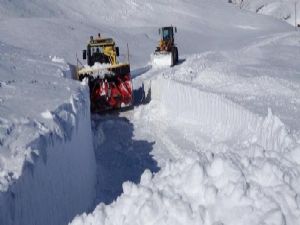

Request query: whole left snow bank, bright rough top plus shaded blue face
[{"left": 0, "top": 54, "right": 96, "bottom": 225}]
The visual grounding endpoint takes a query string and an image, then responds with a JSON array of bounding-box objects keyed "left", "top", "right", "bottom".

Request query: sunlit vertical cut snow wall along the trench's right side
[{"left": 152, "top": 78, "right": 293, "bottom": 151}]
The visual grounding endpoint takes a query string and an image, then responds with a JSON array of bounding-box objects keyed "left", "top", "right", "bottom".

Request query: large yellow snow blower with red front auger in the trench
[{"left": 77, "top": 34, "right": 133, "bottom": 112}]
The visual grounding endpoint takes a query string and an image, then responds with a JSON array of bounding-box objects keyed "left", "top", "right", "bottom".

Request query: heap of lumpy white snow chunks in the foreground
[{"left": 72, "top": 154, "right": 300, "bottom": 225}]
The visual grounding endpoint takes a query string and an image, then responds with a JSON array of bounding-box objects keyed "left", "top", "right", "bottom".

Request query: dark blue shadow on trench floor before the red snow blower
[{"left": 93, "top": 115, "right": 159, "bottom": 204}]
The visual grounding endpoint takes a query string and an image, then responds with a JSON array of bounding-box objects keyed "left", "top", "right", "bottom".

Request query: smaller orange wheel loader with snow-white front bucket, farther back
[{"left": 151, "top": 26, "right": 178, "bottom": 66}]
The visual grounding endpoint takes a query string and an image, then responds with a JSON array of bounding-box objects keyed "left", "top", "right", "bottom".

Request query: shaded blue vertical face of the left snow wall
[{"left": 0, "top": 86, "right": 96, "bottom": 225}]
